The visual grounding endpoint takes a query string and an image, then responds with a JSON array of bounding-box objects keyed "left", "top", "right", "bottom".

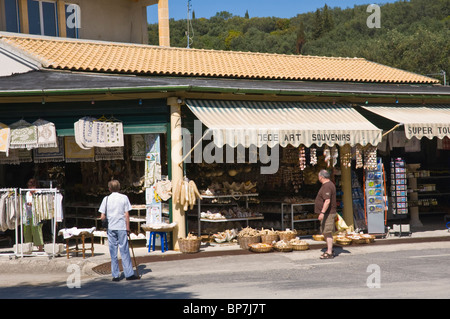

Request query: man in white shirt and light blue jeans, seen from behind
[{"left": 98, "top": 180, "right": 139, "bottom": 281}]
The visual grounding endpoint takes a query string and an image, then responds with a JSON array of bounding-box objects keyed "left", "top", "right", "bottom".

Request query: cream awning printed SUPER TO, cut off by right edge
[{"left": 362, "top": 104, "right": 450, "bottom": 139}]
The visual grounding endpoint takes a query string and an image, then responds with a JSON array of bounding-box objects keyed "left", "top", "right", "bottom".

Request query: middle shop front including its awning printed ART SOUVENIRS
[{"left": 178, "top": 100, "right": 385, "bottom": 236}]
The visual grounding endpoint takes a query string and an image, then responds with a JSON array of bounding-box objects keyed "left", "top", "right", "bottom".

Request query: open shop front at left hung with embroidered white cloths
[{"left": 0, "top": 100, "right": 169, "bottom": 256}]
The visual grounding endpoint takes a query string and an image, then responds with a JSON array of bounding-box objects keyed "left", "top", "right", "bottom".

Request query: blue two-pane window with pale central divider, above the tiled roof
[{"left": 28, "top": 0, "right": 58, "bottom": 36}]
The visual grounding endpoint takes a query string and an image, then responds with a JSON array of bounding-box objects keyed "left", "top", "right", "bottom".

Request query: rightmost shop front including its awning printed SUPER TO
[{"left": 357, "top": 104, "right": 450, "bottom": 231}]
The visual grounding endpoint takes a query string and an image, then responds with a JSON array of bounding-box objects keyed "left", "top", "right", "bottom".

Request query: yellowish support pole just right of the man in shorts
[{"left": 340, "top": 144, "right": 354, "bottom": 228}]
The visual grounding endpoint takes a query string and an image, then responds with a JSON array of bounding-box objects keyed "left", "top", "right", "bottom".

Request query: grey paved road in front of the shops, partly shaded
[{"left": 0, "top": 242, "right": 450, "bottom": 302}]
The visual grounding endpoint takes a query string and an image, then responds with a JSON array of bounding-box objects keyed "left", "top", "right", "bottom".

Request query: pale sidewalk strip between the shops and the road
[{"left": 0, "top": 229, "right": 450, "bottom": 276}]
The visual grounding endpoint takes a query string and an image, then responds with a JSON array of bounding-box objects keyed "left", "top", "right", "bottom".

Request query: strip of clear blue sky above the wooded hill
[{"left": 148, "top": 0, "right": 396, "bottom": 23}]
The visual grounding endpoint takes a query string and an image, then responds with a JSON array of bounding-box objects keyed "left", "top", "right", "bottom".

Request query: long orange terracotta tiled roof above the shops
[{"left": 0, "top": 33, "right": 438, "bottom": 83}]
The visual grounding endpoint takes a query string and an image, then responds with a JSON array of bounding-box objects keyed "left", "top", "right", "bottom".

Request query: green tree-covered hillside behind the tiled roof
[{"left": 148, "top": 0, "right": 450, "bottom": 83}]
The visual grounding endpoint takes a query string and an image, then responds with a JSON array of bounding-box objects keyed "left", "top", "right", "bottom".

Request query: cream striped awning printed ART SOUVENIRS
[{"left": 186, "top": 100, "right": 382, "bottom": 147}]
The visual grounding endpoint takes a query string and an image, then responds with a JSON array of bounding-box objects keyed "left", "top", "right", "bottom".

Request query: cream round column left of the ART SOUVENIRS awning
[{"left": 167, "top": 97, "right": 186, "bottom": 250}]
